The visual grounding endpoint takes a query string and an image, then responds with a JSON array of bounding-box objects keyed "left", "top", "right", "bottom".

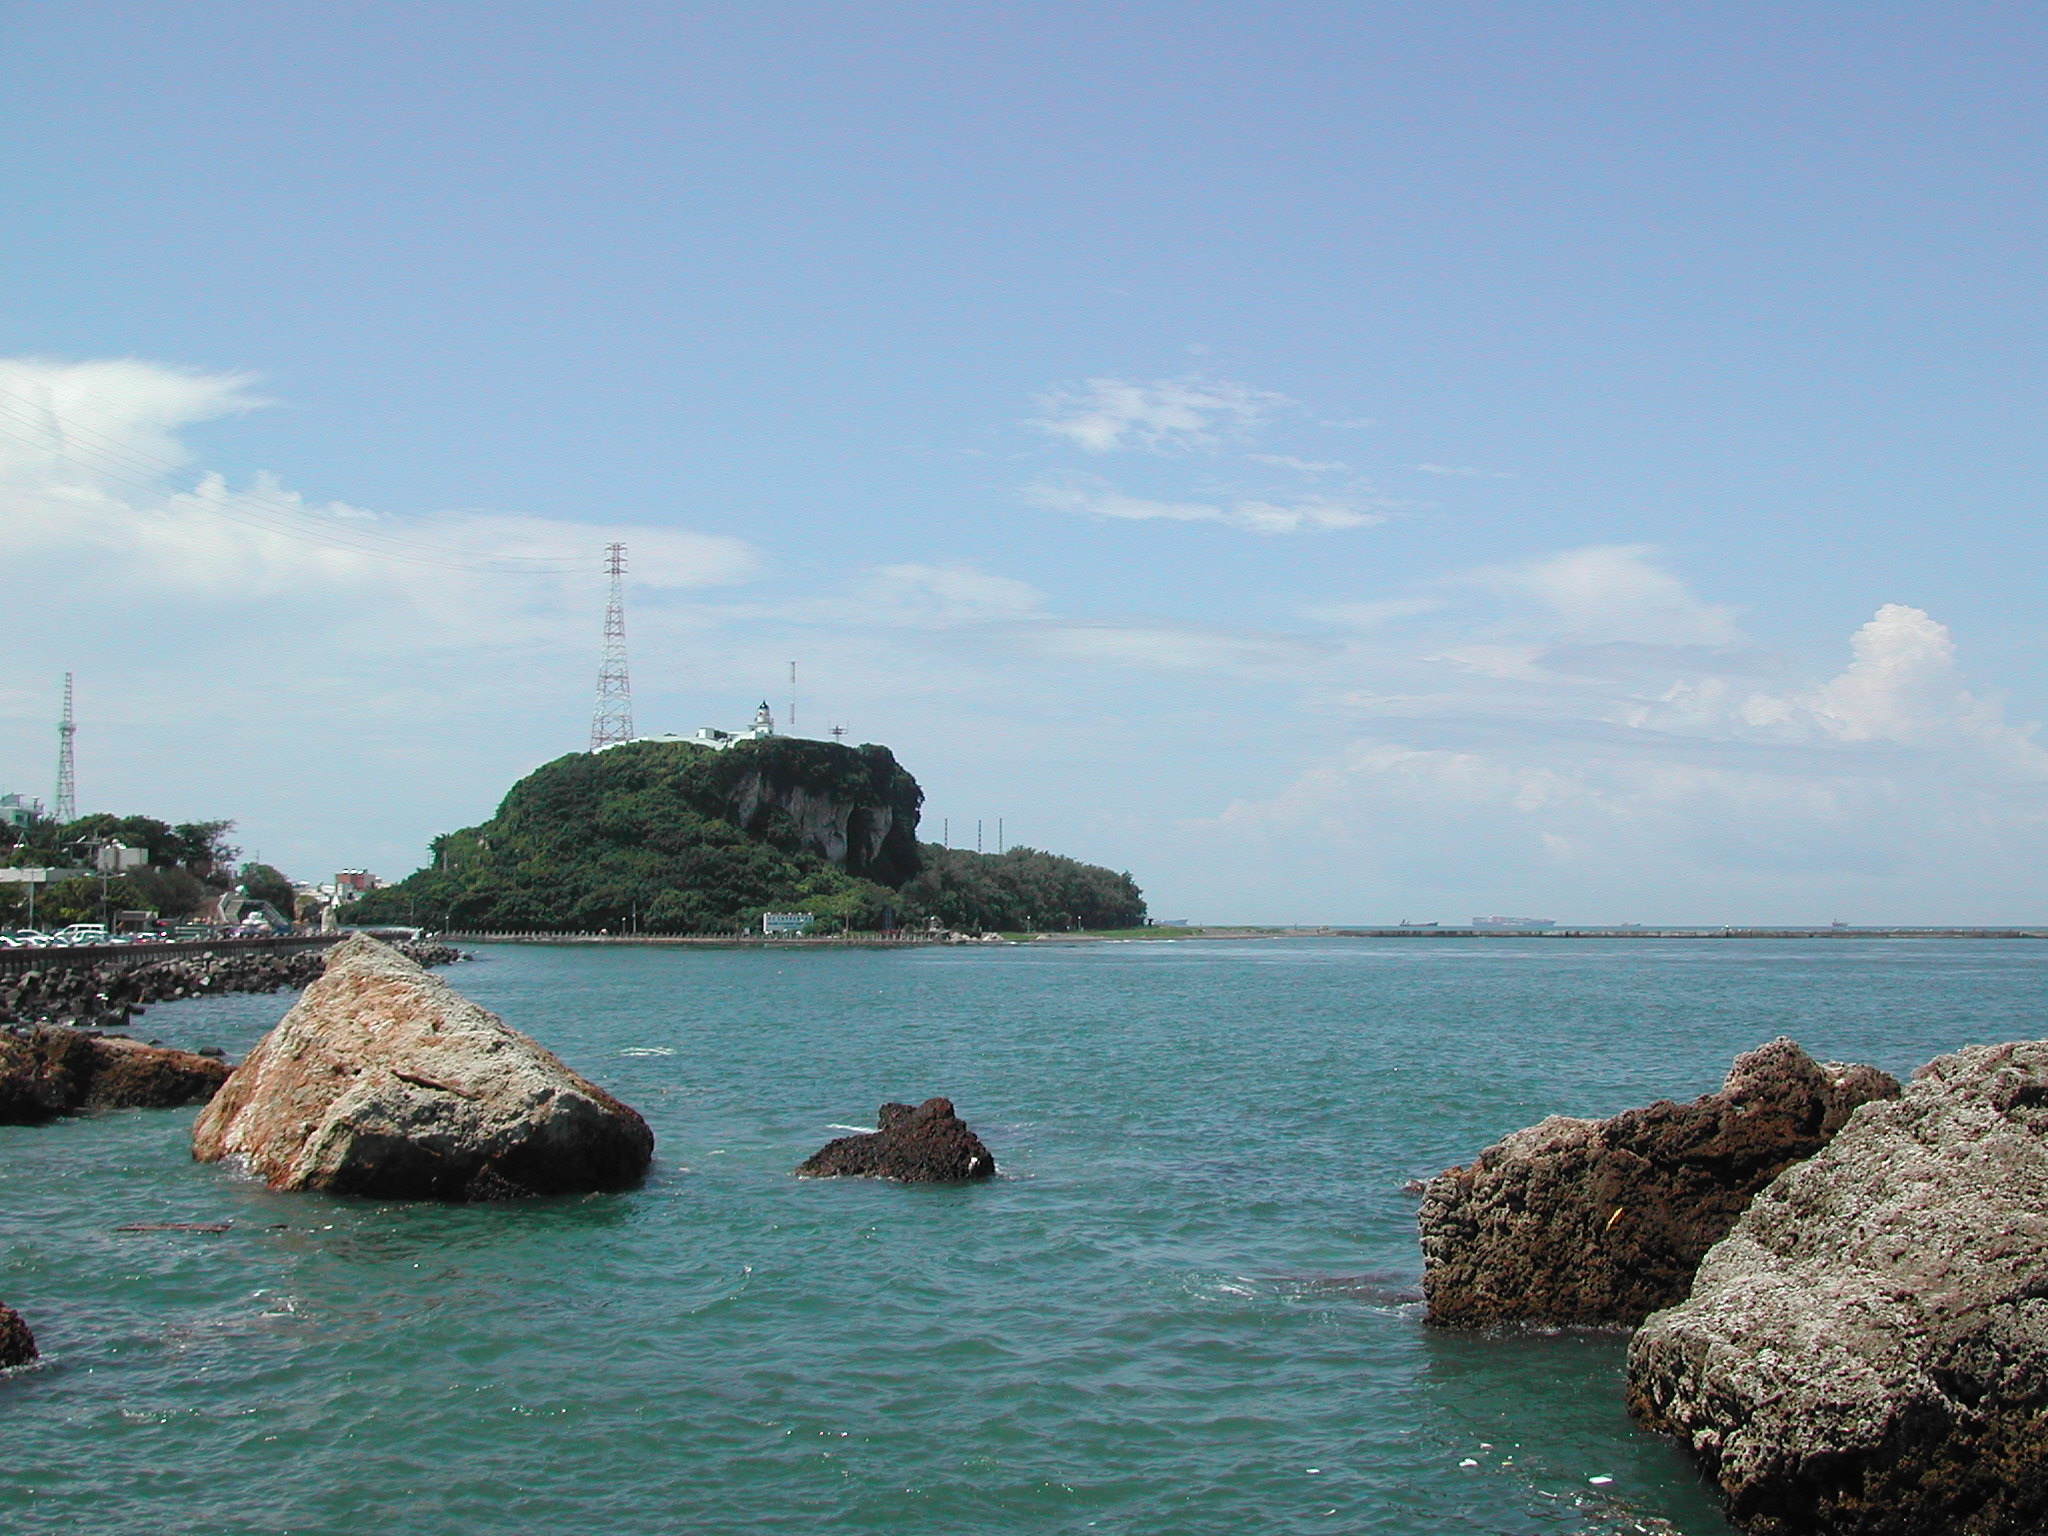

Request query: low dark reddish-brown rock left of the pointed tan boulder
[{"left": 0, "top": 1024, "right": 227, "bottom": 1124}]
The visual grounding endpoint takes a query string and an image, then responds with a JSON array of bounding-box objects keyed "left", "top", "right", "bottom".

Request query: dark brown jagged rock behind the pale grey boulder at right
[{"left": 1417, "top": 1038, "right": 1898, "bottom": 1327}]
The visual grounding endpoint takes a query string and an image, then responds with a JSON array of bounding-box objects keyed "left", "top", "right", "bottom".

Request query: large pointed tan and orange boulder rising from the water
[{"left": 193, "top": 934, "right": 653, "bottom": 1200}]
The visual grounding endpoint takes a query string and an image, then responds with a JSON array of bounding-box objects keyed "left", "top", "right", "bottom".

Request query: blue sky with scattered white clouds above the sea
[{"left": 0, "top": 0, "right": 2048, "bottom": 922}]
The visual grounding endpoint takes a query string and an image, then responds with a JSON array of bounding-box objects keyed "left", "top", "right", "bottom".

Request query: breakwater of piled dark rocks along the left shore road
[{"left": 0, "top": 934, "right": 461, "bottom": 1030}]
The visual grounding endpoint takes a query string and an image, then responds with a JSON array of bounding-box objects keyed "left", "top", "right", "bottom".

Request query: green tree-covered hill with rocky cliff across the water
[{"left": 340, "top": 737, "right": 1145, "bottom": 934}]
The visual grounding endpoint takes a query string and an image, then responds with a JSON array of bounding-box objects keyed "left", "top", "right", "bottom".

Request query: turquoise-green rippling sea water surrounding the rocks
[{"left": 0, "top": 938, "right": 2048, "bottom": 1536}]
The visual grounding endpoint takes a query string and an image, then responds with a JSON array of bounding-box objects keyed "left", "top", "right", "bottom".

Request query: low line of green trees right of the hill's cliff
[{"left": 903, "top": 844, "right": 1145, "bottom": 932}]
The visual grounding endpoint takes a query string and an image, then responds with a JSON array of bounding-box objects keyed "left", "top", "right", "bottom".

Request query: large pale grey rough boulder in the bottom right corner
[{"left": 1628, "top": 1040, "right": 2048, "bottom": 1536}]
